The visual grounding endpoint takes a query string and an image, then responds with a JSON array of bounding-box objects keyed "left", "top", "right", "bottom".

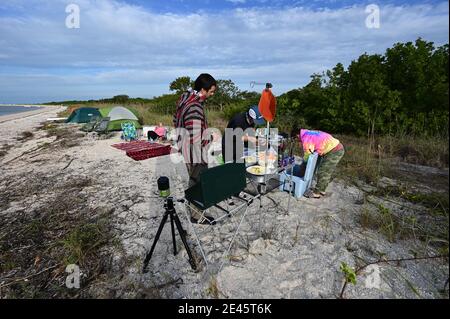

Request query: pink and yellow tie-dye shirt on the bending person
[{"left": 299, "top": 129, "right": 340, "bottom": 161}]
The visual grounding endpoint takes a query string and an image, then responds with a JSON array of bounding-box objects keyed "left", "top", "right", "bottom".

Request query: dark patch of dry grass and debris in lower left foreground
[{"left": 0, "top": 173, "right": 116, "bottom": 298}]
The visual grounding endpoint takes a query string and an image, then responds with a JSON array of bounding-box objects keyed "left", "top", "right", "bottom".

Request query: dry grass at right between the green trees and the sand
[{"left": 337, "top": 136, "right": 449, "bottom": 254}]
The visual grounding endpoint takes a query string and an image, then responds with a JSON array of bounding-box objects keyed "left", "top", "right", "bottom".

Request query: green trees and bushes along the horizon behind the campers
[{"left": 48, "top": 38, "right": 449, "bottom": 137}]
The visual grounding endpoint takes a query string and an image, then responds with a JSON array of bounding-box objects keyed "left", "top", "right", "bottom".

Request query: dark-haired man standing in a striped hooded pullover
[{"left": 173, "top": 73, "right": 217, "bottom": 224}]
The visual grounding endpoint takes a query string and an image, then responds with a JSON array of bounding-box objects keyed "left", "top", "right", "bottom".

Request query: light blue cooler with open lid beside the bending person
[{"left": 280, "top": 153, "right": 318, "bottom": 198}]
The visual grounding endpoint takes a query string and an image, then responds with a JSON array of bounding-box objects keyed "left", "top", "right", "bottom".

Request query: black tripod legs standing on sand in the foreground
[{"left": 143, "top": 197, "right": 197, "bottom": 272}]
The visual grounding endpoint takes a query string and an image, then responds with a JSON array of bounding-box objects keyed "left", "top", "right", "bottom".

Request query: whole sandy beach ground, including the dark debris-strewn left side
[{"left": 0, "top": 107, "right": 449, "bottom": 298}]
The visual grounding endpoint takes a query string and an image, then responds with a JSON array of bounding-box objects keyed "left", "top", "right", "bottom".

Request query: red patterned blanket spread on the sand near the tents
[{"left": 111, "top": 141, "right": 172, "bottom": 161}]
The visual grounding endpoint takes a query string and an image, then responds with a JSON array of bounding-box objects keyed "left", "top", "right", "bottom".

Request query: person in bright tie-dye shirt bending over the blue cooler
[{"left": 295, "top": 129, "right": 345, "bottom": 198}]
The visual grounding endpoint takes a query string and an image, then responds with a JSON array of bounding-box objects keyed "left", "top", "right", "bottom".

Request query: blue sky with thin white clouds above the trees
[{"left": 0, "top": 0, "right": 449, "bottom": 104}]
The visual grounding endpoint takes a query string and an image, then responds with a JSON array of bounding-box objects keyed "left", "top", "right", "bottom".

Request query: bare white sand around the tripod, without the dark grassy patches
[{"left": 0, "top": 107, "right": 448, "bottom": 298}]
